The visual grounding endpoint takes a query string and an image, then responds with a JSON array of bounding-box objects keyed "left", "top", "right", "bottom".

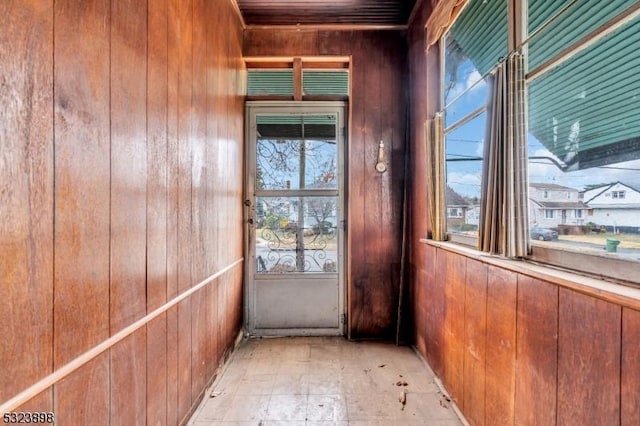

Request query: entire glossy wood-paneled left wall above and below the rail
[{"left": 0, "top": 0, "right": 244, "bottom": 424}]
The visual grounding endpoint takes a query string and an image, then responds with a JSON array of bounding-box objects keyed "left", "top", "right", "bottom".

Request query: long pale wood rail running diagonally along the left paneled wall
[{"left": 0, "top": 258, "right": 244, "bottom": 413}]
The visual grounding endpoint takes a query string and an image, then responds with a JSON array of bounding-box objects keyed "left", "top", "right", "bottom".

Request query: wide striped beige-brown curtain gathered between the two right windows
[{"left": 478, "top": 53, "right": 529, "bottom": 257}]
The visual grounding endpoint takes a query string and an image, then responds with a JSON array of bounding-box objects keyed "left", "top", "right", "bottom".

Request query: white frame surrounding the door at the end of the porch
[{"left": 243, "top": 101, "right": 348, "bottom": 336}]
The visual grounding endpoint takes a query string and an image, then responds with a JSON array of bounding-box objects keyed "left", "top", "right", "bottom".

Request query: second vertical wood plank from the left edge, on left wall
[{"left": 53, "top": 0, "right": 110, "bottom": 424}]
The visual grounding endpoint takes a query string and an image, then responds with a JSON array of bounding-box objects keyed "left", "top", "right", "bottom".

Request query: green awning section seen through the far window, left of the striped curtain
[{"left": 447, "top": 0, "right": 507, "bottom": 75}]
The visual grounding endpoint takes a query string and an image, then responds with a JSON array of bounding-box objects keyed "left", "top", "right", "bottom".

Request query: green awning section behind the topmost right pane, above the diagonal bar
[{"left": 529, "top": 0, "right": 637, "bottom": 70}]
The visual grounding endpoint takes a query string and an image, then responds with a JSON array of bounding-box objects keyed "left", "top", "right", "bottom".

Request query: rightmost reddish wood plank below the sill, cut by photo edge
[{"left": 620, "top": 308, "right": 640, "bottom": 426}]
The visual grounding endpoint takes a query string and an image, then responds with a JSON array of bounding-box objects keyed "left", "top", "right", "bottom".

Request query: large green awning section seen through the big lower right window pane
[{"left": 529, "top": 19, "right": 640, "bottom": 170}]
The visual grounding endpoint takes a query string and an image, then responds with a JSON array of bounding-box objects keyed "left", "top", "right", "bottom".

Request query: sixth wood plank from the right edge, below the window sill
[{"left": 440, "top": 250, "right": 467, "bottom": 405}]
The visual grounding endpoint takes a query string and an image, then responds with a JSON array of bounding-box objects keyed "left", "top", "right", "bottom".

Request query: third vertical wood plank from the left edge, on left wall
[{"left": 109, "top": 0, "right": 147, "bottom": 424}]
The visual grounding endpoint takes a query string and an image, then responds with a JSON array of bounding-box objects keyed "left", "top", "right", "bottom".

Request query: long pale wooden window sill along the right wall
[{"left": 420, "top": 239, "right": 640, "bottom": 309}]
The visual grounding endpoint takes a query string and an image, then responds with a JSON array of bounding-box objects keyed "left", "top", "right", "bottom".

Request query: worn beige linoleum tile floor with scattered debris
[{"left": 188, "top": 337, "right": 466, "bottom": 426}]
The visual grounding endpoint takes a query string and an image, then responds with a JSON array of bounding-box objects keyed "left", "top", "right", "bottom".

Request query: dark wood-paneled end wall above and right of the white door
[{"left": 244, "top": 29, "right": 407, "bottom": 339}]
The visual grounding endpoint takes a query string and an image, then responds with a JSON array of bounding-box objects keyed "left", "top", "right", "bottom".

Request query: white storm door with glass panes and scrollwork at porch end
[{"left": 245, "top": 102, "right": 345, "bottom": 336}]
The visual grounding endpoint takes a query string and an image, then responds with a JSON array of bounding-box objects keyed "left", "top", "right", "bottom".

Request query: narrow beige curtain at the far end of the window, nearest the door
[{"left": 424, "top": 113, "right": 447, "bottom": 241}]
